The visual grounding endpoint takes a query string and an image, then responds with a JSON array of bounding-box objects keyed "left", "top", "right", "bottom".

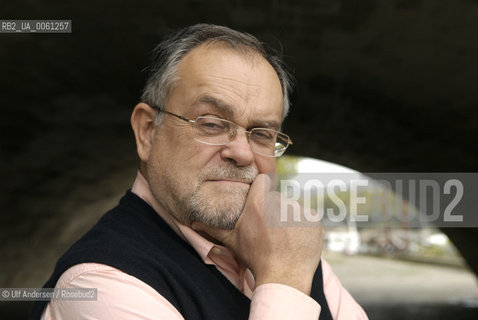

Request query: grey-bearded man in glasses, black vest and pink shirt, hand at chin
[{"left": 32, "top": 24, "right": 366, "bottom": 319}]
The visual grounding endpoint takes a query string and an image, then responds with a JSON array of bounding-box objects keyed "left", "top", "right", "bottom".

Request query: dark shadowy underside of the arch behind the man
[{"left": 0, "top": 0, "right": 478, "bottom": 319}]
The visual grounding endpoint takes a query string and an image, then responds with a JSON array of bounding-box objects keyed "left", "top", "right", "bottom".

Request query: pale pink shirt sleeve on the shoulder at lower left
[{"left": 41, "top": 263, "right": 184, "bottom": 320}]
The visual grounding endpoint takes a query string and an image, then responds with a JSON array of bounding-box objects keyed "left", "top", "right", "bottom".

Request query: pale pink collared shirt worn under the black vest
[{"left": 41, "top": 173, "right": 368, "bottom": 320}]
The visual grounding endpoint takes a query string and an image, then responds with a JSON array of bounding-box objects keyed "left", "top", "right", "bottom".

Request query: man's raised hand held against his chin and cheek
[{"left": 192, "top": 174, "right": 323, "bottom": 295}]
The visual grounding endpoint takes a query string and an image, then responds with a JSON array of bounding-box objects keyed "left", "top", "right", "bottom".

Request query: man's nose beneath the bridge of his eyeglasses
[{"left": 221, "top": 129, "right": 254, "bottom": 167}]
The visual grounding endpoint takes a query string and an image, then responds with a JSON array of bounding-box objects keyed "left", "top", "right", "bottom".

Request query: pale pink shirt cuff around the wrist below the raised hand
[{"left": 249, "top": 283, "right": 320, "bottom": 320}]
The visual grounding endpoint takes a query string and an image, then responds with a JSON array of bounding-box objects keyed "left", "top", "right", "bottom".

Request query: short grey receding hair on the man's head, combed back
[{"left": 141, "top": 24, "right": 292, "bottom": 124}]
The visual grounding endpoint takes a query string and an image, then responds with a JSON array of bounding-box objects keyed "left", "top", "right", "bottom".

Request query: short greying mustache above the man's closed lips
[{"left": 199, "top": 164, "right": 259, "bottom": 184}]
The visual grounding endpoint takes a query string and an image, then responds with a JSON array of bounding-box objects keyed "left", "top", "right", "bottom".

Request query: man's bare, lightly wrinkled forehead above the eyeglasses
[{"left": 170, "top": 44, "right": 283, "bottom": 122}]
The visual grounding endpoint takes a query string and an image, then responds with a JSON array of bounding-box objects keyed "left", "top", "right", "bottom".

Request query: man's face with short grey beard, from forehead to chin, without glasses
[{"left": 147, "top": 45, "right": 283, "bottom": 229}]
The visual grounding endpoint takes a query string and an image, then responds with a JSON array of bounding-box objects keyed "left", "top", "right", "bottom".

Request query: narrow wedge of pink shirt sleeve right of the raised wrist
[{"left": 321, "top": 259, "right": 368, "bottom": 320}]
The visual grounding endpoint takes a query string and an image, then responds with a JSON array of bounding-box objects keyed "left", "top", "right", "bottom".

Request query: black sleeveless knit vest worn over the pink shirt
[{"left": 30, "top": 191, "right": 332, "bottom": 320}]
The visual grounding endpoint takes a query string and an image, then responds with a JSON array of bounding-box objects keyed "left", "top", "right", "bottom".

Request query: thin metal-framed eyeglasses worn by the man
[{"left": 152, "top": 106, "right": 292, "bottom": 157}]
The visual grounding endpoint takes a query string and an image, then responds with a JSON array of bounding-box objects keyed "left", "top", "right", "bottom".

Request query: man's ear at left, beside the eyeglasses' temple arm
[{"left": 131, "top": 102, "right": 156, "bottom": 163}]
